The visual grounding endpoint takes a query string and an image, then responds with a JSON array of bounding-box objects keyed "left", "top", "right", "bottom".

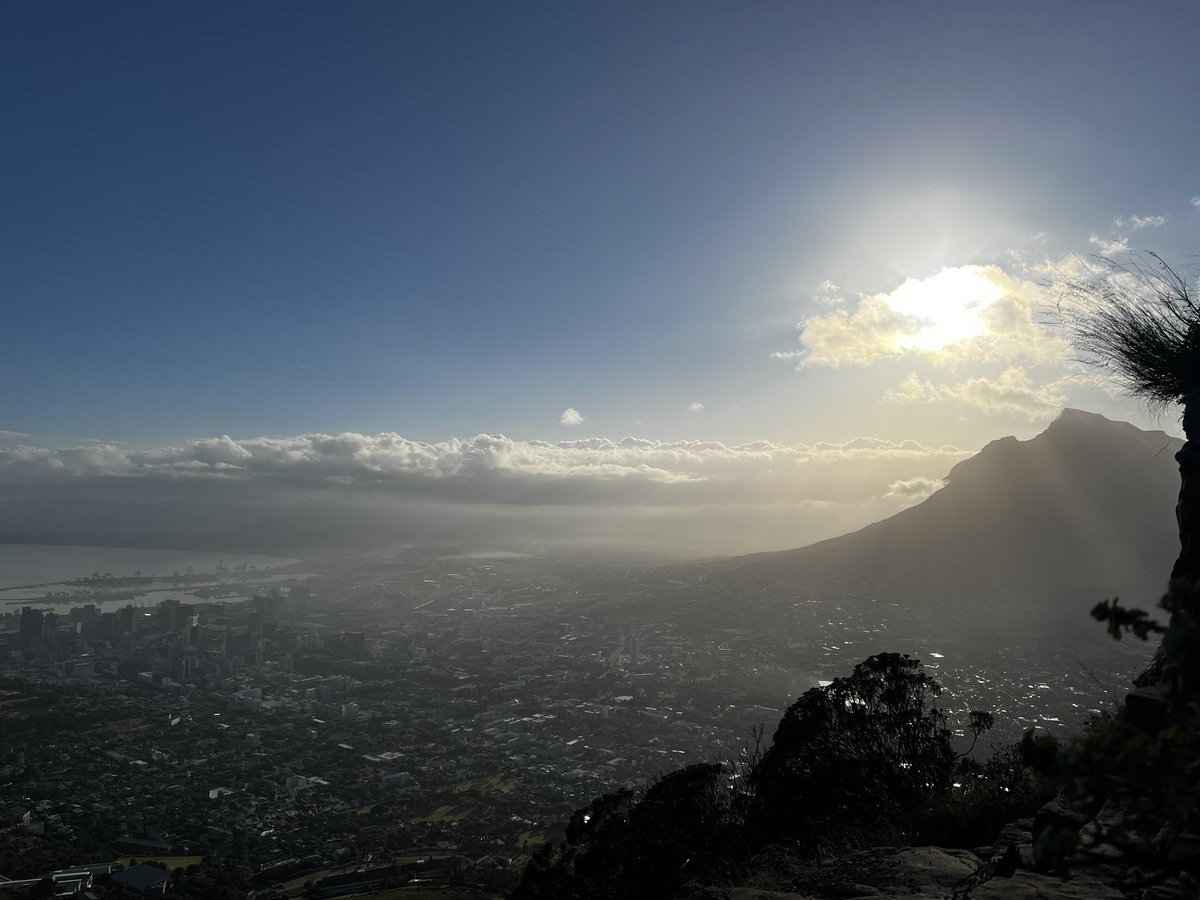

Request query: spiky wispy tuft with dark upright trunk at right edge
[{"left": 1058, "top": 253, "right": 1200, "bottom": 582}]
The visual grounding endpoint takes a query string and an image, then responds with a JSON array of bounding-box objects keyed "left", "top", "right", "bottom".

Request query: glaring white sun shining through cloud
[{"left": 884, "top": 265, "right": 1004, "bottom": 352}]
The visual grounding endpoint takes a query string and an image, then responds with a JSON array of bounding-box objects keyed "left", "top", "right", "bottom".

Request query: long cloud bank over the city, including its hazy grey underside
[{"left": 0, "top": 433, "right": 988, "bottom": 554}]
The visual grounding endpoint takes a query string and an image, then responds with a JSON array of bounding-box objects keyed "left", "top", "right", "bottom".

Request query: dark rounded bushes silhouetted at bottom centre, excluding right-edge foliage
[{"left": 514, "top": 654, "right": 1052, "bottom": 900}]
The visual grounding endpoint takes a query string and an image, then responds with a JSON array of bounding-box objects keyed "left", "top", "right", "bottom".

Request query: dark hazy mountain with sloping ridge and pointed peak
[{"left": 715, "top": 409, "right": 1182, "bottom": 628}]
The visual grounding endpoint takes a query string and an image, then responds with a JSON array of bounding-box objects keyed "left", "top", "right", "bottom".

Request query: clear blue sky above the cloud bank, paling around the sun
[{"left": 0, "top": 0, "right": 1200, "bottom": 448}]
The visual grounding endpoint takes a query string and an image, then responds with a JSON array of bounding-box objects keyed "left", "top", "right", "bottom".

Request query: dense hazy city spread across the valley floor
[{"left": 0, "top": 553, "right": 1144, "bottom": 896}]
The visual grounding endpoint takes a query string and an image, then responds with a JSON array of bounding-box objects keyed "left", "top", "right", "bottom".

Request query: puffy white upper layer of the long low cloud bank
[{"left": 0, "top": 433, "right": 970, "bottom": 513}]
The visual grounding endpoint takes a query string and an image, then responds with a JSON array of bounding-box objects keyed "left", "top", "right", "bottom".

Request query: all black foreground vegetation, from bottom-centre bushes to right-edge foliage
[{"left": 512, "top": 581, "right": 1200, "bottom": 900}]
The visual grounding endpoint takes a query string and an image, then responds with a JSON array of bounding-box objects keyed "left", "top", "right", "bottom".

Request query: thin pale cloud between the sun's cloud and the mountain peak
[{"left": 883, "top": 366, "right": 1067, "bottom": 421}]
